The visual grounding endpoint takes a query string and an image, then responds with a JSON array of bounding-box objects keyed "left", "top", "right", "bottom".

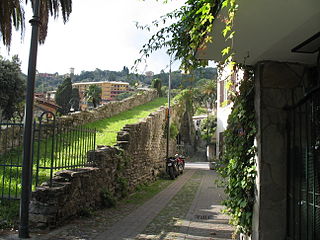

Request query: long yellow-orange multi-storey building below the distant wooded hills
[{"left": 72, "top": 81, "right": 129, "bottom": 109}]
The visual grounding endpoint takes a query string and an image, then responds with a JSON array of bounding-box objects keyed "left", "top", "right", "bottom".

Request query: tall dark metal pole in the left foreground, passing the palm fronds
[{"left": 19, "top": 0, "right": 40, "bottom": 238}]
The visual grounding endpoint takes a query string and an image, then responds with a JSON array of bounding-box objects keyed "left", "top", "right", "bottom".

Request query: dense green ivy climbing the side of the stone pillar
[{"left": 218, "top": 68, "right": 256, "bottom": 234}]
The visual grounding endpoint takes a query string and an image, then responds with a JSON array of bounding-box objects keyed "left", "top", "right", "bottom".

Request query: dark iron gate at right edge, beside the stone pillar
[{"left": 287, "top": 88, "right": 320, "bottom": 240}]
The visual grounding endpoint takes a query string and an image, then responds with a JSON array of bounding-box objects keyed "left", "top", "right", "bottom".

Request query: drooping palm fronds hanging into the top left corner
[{"left": 0, "top": 0, "right": 72, "bottom": 47}]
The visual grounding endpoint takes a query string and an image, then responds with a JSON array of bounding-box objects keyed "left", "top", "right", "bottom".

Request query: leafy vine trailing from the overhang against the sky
[{"left": 135, "top": 0, "right": 238, "bottom": 72}]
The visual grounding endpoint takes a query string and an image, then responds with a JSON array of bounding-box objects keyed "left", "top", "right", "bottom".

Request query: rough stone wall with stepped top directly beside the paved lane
[{"left": 30, "top": 98, "right": 190, "bottom": 228}]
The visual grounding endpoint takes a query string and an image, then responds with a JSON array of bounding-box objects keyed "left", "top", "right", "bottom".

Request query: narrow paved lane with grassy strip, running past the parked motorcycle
[{"left": 0, "top": 162, "right": 233, "bottom": 240}]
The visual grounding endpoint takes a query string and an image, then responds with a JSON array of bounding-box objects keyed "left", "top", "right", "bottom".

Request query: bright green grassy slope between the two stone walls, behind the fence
[{"left": 0, "top": 98, "right": 166, "bottom": 199}]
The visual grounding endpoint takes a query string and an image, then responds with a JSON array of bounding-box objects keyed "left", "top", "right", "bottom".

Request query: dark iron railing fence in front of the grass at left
[{"left": 0, "top": 113, "right": 96, "bottom": 200}]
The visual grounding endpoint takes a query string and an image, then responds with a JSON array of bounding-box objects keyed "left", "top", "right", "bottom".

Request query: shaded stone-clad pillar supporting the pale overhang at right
[{"left": 252, "top": 62, "right": 305, "bottom": 240}]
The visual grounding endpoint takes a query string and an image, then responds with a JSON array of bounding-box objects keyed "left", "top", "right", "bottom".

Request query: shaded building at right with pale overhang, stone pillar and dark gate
[{"left": 197, "top": 0, "right": 320, "bottom": 240}]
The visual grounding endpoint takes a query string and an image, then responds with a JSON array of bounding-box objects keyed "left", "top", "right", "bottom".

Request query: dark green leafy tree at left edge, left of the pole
[{"left": 0, "top": 56, "right": 25, "bottom": 120}]
